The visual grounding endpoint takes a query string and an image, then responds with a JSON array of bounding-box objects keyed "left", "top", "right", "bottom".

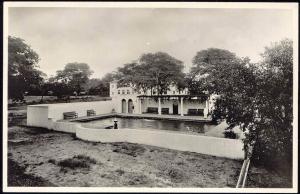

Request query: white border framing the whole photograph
[{"left": 2, "top": 2, "right": 299, "bottom": 193}]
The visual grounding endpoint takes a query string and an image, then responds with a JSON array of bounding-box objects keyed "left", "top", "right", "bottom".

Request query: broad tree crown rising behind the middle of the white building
[{"left": 116, "top": 52, "right": 184, "bottom": 95}]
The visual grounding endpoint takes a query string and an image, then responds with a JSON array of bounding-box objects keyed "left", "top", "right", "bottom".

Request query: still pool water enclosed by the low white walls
[{"left": 82, "top": 117, "right": 216, "bottom": 133}]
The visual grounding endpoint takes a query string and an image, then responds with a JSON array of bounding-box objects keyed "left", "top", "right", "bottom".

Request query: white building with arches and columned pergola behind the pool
[{"left": 110, "top": 81, "right": 215, "bottom": 118}]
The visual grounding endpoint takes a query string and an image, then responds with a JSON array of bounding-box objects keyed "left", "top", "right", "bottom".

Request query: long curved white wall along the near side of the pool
[{"left": 76, "top": 126, "right": 244, "bottom": 159}]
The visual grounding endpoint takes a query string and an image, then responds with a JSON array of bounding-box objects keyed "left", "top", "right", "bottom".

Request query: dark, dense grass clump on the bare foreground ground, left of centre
[{"left": 57, "top": 155, "right": 97, "bottom": 170}]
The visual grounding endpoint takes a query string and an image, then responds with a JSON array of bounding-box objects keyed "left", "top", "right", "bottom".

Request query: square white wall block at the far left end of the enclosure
[{"left": 27, "top": 105, "right": 48, "bottom": 128}]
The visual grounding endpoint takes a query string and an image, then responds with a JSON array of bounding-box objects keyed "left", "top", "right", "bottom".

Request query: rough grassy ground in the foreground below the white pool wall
[{"left": 8, "top": 105, "right": 287, "bottom": 188}]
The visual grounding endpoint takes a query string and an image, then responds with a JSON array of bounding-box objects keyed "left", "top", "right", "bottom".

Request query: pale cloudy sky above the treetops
[{"left": 8, "top": 7, "right": 293, "bottom": 78}]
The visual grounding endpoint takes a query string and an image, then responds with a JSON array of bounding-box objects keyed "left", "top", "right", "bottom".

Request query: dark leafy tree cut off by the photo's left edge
[{"left": 8, "top": 36, "right": 45, "bottom": 101}]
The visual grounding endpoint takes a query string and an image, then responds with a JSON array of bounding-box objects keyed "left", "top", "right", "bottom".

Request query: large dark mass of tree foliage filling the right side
[{"left": 200, "top": 40, "right": 293, "bottom": 172}]
